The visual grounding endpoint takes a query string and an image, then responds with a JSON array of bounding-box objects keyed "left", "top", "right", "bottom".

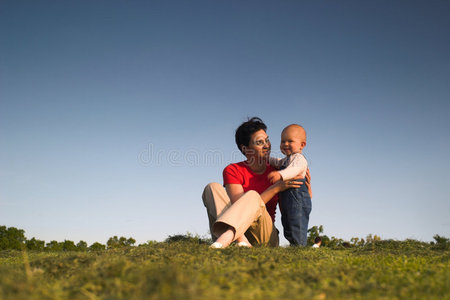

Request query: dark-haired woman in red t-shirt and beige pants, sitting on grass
[{"left": 202, "top": 117, "right": 310, "bottom": 248}]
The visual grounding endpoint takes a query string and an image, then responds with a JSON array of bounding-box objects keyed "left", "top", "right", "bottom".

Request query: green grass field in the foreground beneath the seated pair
[{"left": 0, "top": 239, "right": 450, "bottom": 299}]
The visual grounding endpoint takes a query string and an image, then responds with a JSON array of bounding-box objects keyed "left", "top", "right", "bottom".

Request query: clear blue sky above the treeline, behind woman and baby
[{"left": 0, "top": 0, "right": 450, "bottom": 243}]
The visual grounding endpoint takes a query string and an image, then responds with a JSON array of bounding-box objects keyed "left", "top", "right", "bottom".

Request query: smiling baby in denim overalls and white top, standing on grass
[{"left": 268, "top": 124, "right": 311, "bottom": 246}]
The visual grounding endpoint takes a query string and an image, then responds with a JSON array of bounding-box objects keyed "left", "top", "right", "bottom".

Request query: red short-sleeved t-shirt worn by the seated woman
[{"left": 223, "top": 161, "right": 278, "bottom": 223}]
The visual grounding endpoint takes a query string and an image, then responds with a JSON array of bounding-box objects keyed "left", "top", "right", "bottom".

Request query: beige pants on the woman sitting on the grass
[{"left": 202, "top": 182, "right": 279, "bottom": 247}]
